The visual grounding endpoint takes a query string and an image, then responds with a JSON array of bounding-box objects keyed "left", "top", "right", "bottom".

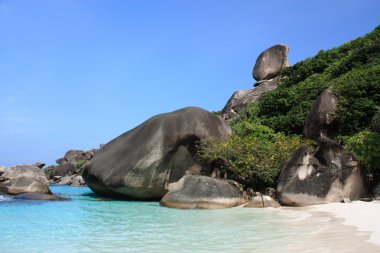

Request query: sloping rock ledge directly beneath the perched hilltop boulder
[{"left": 222, "top": 79, "right": 278, "bottom": 120}]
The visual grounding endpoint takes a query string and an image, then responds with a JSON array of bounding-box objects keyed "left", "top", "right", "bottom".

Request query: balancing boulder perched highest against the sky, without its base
[{"left": 252, "top": 45, "right": 289, "bottom": 81}]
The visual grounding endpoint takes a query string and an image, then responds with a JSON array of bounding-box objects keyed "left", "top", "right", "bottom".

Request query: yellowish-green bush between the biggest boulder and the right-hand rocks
[{"left": 199, "top": 121, "right": 302, "bottom": 187}]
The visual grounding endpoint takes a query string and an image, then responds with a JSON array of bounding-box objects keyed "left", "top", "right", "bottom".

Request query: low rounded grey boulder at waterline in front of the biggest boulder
[{"left": 160, "top": 176, "right": 247, "bottom": 209}]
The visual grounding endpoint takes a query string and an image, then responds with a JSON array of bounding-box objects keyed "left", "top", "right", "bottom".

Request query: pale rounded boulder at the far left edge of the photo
[{"left": 0, "top": 165, "right": 51, "bottom": 195}]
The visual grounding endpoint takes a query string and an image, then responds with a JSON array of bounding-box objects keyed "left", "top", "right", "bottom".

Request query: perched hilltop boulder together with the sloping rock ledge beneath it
[{"left": 222, "top": 45, "right": 289, "bottom": 120}]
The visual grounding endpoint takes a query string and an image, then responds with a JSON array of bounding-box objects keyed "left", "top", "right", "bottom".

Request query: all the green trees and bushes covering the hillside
[{"left": 201, "top": 26, "right": 380, "bottom": 189}]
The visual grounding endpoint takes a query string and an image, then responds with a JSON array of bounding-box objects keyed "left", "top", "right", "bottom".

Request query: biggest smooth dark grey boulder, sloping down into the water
[{"left": 82, "top": 107, "right": 231, "bottom": 200}]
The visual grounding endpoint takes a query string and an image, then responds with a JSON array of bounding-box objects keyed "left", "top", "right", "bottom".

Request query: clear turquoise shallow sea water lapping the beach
[{"left": 0, "top": 186, "right": 380, "bottom": 253}]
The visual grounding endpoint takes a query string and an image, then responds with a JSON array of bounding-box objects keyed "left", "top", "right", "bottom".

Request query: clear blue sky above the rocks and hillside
[{"left": 0, "top": 0, "right": 380, "bottom": 166}]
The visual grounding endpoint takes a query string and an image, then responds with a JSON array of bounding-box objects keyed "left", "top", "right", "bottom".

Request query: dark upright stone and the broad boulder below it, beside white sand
[{"left": 277, "top": 89, "right": 367, "bottom": 206}]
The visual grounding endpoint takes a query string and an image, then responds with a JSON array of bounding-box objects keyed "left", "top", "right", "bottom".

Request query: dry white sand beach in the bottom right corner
[{"left": 306, "top": 201, "right": 380, "bottom": 246}]
